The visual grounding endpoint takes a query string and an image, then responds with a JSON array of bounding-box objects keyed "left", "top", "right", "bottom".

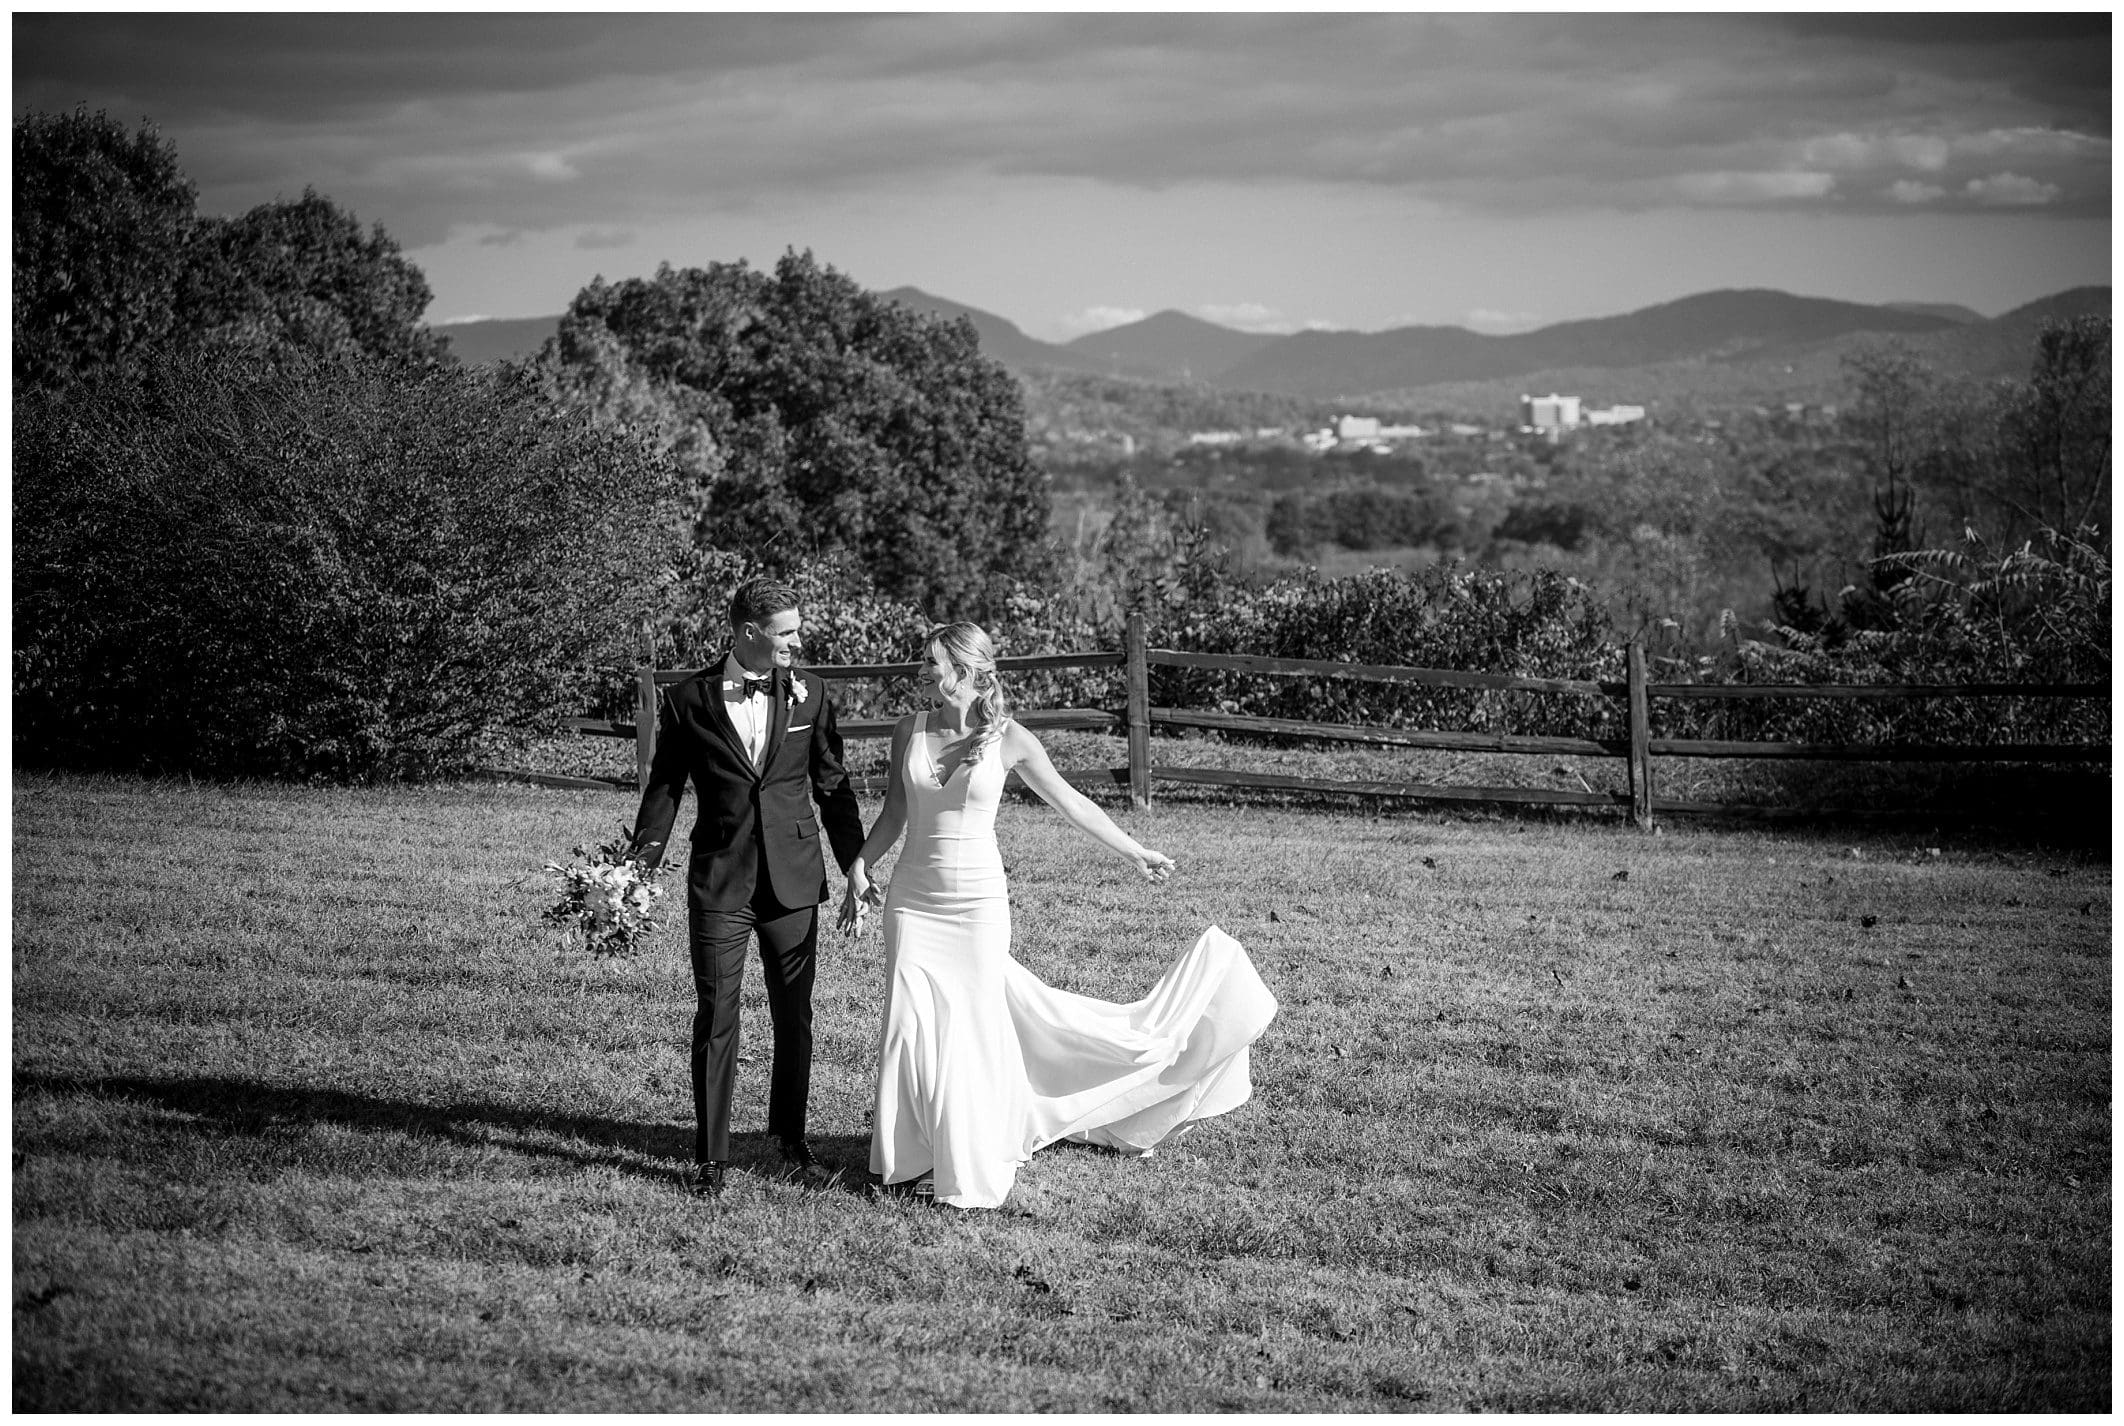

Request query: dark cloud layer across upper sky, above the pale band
[{"left": 15, "top": 15, "right": 2109, "bottom": 244}]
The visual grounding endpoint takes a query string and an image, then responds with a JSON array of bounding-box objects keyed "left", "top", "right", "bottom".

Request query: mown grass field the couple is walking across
[{"left": 13, "top": 774, "right": 2111, "bottom": 1411}]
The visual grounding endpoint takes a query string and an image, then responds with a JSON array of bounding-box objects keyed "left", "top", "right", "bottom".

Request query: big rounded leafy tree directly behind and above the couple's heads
[{"left": 542, "top": 251, "right": 1049, "bottom": 616}]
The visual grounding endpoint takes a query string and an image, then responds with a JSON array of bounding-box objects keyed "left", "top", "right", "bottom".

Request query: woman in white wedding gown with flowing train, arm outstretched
[{"left": 841, "top": 623, "right": 1277, "bottom": 1207}]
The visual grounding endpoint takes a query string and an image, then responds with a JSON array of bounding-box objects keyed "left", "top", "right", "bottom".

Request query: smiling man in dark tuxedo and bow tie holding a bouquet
[{"left": 633, "top": 578, "right": 862, "bottom": 1194}]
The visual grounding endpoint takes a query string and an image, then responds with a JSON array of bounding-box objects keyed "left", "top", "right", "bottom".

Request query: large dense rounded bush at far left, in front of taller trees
[{"left": 15, "top": 351, "right": 684, "bottom": 780}]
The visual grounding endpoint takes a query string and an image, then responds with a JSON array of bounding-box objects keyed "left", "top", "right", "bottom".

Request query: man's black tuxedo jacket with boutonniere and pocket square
[{"left": 633, "top": 655, "right": 862, "bottom": 912}]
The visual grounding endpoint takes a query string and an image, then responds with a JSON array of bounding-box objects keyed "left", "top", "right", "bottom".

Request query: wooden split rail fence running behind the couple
[{"left": 542, "top": 616, "right": 2109, "bottom": 829}]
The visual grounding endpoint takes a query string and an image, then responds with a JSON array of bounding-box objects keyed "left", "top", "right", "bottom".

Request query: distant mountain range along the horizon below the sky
[{"left": 442, "top": 287, "right": 2109, "bottom": 400}]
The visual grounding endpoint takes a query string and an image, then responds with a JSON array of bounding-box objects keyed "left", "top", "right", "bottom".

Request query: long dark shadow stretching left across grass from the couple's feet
[{"left": 15, "top": 1073, "right": 871, "bottom": 1194}]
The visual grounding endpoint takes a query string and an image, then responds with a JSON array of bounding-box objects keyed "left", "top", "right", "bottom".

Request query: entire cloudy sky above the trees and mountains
[{"left": 13, "top": 11, "right": 2111, "bottom": 340}]
